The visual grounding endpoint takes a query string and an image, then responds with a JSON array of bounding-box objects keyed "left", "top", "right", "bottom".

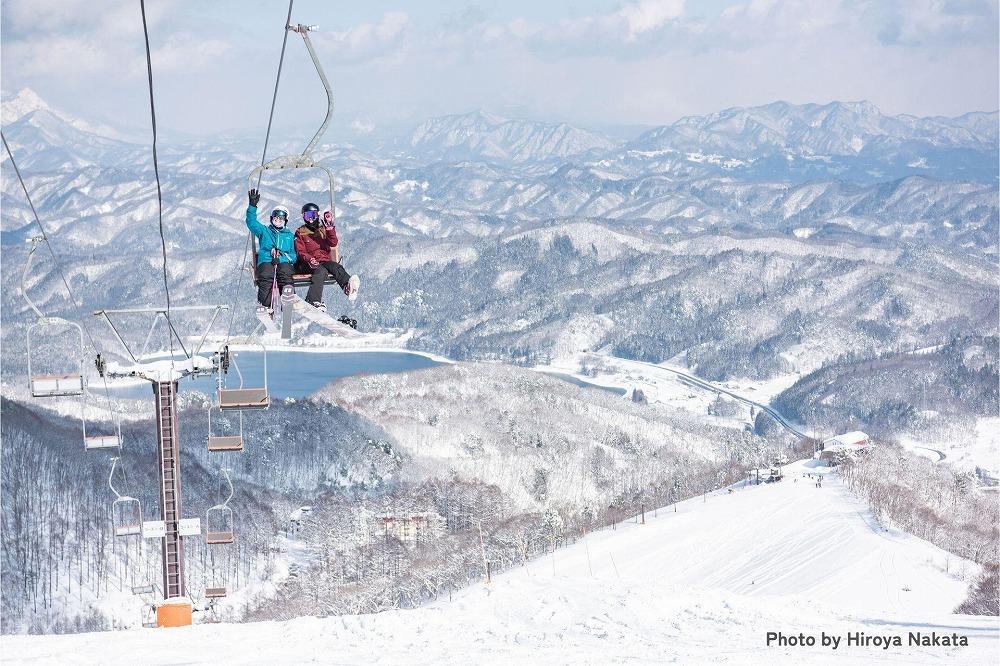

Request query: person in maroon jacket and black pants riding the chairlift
[{"left": 295, "top": 203, "right": 361, "bottom": 310}]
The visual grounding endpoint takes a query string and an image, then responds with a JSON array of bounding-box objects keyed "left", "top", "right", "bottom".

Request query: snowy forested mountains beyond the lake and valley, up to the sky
[{"left": 0, "top": 91, "right": 998, "bottom": 386}]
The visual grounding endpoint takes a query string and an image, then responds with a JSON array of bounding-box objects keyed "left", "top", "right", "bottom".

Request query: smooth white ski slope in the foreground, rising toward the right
[{"left": 2, "top": 461, "right": 1000, "bottom": 664}]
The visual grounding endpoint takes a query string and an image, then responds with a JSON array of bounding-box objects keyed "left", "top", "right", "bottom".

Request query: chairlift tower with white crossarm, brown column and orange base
[{"left": 94, "top": 305, "right": 229, "bottom": 627}]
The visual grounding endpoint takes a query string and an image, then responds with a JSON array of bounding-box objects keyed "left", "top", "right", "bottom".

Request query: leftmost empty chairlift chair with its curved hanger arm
[{"left": 21, "top": 236, "right": 86, "bottom": 398}]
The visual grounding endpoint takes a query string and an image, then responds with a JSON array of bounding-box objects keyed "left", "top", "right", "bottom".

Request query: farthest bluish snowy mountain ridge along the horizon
[{"left": 3, "top": 89, "right": 1000, "bottom": 185}]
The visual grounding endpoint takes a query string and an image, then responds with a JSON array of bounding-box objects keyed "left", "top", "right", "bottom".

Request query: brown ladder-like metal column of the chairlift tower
[{"left": 153, "top": 382, "right": 184, "bottom": 599}]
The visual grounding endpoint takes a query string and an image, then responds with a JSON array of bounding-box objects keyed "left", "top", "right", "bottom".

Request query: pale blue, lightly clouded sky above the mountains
[{"left": 0, "top": 0, "right": 1000, "bottom": 133}]
